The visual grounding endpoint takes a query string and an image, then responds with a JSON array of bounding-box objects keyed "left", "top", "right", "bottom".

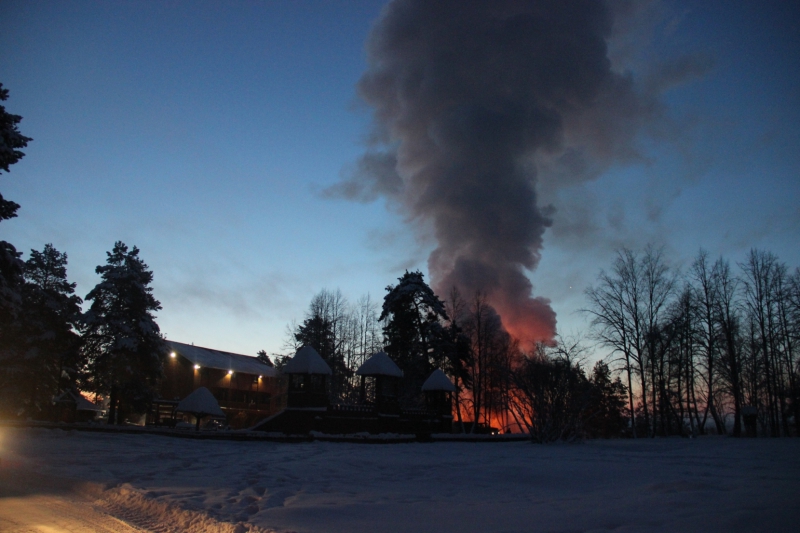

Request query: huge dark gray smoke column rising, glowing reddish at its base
[{"left": 328, "top": 0, "right": 656, "bottom": 340}]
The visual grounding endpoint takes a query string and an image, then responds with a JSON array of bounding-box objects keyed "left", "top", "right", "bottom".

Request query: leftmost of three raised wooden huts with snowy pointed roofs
[{"left": 283, "top": 346, "right": 333, "bottom": 409}]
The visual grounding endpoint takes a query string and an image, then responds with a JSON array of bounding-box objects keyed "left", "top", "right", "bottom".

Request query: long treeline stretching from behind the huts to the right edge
[{"left": 277, "top": 246, "right": 800, "bottom": 441}]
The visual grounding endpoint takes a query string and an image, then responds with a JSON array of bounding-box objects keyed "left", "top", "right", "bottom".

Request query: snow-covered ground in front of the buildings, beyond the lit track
[{"left": 0, "top": 428, "right": 800, "bottom": 533}]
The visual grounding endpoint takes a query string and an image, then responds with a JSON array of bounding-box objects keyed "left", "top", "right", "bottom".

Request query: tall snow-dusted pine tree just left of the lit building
[{"left": 82, "top": 241, "right": 167, "bottom": 424}]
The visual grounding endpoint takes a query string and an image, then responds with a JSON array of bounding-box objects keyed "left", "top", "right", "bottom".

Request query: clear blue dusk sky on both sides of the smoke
[{"left": 0, "top": 0, "right": 800, "bottom": 355}]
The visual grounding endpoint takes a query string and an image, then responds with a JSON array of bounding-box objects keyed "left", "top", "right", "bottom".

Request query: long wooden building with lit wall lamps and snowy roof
[{"left": 152, "top": 341, "right": 286, "bottom": 428}]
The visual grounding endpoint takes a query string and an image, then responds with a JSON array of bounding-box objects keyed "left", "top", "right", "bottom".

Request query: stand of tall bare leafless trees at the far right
[{"left": 586, "top": 246, "right": 800, "bottom": 437}]
